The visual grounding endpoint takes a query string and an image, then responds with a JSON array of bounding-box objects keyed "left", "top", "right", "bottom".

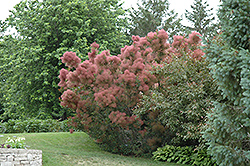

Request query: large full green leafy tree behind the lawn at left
[{"left": 0, "top": 0, "right": 127, "bottom": 120}]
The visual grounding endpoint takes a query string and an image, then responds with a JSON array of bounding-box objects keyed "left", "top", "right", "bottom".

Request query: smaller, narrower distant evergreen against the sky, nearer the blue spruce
[{"left": 185, "top": 0, "right": 219, "bottom": 39}]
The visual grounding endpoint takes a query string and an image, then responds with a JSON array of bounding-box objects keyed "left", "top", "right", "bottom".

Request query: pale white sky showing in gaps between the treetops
[{"left": 0, "top": 0, "right": 220, "bottom": 25}]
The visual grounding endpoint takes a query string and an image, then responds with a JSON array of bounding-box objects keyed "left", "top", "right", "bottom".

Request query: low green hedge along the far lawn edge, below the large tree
[{"left": 0, "top": 119, "right": 72, "bottom": 133}]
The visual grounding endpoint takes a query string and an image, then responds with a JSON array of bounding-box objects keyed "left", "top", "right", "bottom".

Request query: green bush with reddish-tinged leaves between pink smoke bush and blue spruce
[{"left": 134, "top": 34, "right": 219, "bottom": 146}]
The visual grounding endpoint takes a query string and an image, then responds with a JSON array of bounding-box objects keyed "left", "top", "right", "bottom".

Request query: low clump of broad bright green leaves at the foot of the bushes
[{"left": 153, "top": 145, "right": 216, "bottom": 166}]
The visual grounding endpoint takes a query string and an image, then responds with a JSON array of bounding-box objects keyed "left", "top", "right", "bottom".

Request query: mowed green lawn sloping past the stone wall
[{"left": 0, "top": 132, "right": 187, "bottom": 166}]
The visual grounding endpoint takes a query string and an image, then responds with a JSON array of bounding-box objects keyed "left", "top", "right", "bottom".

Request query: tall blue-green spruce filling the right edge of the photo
[{"left": 204, "top": 0, "right": 250, "bottom": 166}]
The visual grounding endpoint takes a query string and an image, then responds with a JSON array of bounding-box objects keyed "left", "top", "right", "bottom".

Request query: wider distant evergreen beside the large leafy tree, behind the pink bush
[{"left": 129, "top": 0, "right": 182, "bottom": 38}]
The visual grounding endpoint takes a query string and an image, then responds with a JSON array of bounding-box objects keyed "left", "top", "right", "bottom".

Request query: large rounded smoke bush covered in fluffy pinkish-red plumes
[{"left": 59, "top": 30, "right": 213, "bottom": 155}]
